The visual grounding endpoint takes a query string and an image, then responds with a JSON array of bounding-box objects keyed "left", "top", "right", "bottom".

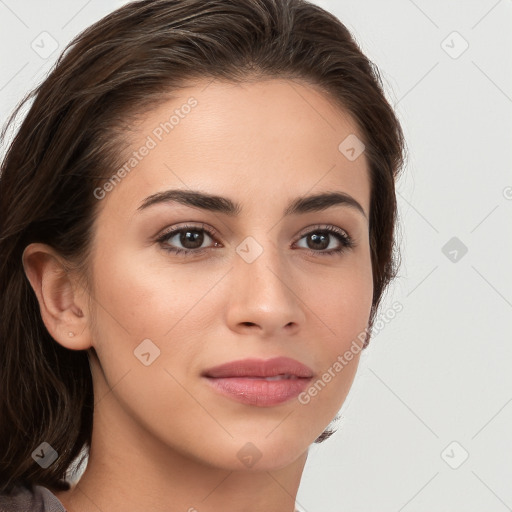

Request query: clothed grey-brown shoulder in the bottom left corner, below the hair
[{"left": 0, "top": 485, "right": 66, "bottom": 512}]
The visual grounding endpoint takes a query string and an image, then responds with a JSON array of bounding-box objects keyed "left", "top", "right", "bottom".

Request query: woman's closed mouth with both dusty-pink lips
[{"left": 201, "top": 357, "right": 313, "bottom": 407}]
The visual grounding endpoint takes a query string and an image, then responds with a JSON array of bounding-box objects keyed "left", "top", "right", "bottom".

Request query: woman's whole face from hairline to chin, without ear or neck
[{"left": 84, "top": 80, "right": 373, "bottom": 469}]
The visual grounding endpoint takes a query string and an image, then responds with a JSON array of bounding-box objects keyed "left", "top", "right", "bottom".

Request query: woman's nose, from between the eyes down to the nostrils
[{"left": 227, "top": 238, "right": 305, "bottom": 338}]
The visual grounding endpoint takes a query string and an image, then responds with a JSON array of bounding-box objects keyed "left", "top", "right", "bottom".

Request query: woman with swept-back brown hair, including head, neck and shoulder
[{"left": 0, "top": 0, "right": 403, "bottom": 512}]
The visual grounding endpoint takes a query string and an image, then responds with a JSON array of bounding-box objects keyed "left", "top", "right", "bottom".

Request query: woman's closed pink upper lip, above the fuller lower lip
[{"left": 202, "top": 357, "right": 313, "bottom": 378}]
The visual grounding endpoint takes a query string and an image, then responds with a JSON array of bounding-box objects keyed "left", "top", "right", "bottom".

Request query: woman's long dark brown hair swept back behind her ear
[{"left": 0, "top": 0, "right": 404, "bottom": 492}]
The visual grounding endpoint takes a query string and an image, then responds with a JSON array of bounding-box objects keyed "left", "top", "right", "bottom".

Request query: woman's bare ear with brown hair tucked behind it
[{"left": 22, "top": 243, "right": 92, "bottom": 350}]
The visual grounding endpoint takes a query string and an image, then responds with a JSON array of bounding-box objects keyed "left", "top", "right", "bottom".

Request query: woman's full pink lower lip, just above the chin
[{"left": 207, "top": 377, "right": 311, "bottom": 407}]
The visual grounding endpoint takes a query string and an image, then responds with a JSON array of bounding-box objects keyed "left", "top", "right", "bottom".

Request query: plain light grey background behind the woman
[{"left": 0, "top": 0, "right": 512, "bottom": 512}]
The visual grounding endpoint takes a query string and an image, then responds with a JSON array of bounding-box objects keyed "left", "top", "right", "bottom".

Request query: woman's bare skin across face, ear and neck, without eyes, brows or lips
[{"left": 23, "top": 79, "right": 373, "bottom": 512}]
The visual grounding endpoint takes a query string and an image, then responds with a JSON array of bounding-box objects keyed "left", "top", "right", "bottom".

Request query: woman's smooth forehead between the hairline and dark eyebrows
[{"left": 98, "top": 79, "right": 370, "bottom": 219}]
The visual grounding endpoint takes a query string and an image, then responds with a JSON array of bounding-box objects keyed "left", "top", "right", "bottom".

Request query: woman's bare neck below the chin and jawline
[{"left": 57, "top": 442, "right": 307, "bottom": 512}]
